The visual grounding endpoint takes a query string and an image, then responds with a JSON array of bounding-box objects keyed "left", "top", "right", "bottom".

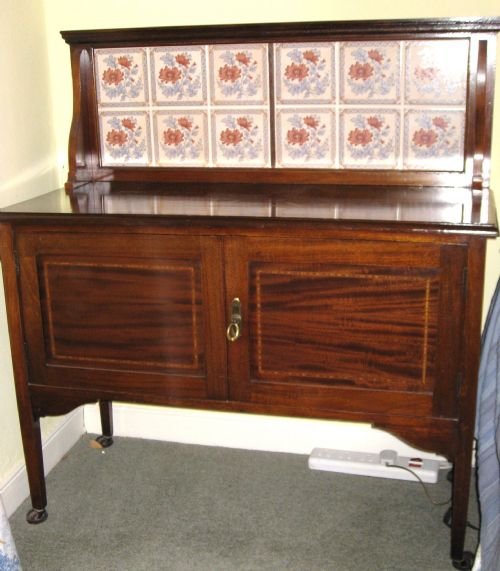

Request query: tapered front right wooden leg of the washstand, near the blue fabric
[{"left": 451, "top": 451, "right": 474, "bottom": 570}]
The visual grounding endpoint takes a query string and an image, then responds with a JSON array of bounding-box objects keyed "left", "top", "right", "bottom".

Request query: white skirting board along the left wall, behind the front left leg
[{"left": 0, "top": 407, "right": 85, "bottom": 517}]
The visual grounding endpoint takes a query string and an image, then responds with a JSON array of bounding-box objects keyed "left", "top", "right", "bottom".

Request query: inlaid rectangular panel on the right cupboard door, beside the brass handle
[{"left": 252, "top": 268, "right": 439, "bottom": 391}]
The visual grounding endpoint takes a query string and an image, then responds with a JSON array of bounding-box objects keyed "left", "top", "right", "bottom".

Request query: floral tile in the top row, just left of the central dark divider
[{"left": 210, "top": 44, "right": 269, "bottom": 105}]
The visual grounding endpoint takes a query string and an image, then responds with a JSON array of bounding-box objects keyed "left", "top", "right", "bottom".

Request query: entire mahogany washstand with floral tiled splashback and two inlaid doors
[{"left": 0, "top": 18, "right": 500, "bottom": 569}]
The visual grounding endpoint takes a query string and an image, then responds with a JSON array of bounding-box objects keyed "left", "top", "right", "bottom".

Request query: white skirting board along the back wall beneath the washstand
[{"left": 85, "top": 403, "right": 441, "bottom": 459}]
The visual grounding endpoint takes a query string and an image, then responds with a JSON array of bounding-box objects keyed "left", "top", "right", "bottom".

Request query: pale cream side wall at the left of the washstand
[{"left": 0, "top": 0, "right": 64, "bottom": 489}]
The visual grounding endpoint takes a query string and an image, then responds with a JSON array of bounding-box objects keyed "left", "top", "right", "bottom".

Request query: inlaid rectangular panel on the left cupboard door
[{"left": 42, "top": 259, "right": 205, "bottom": 375}]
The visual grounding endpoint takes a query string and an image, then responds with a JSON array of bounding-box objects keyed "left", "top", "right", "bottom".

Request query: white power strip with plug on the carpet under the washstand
[{"left": 309, "top": 448, "right": 440, "bottom": 484}]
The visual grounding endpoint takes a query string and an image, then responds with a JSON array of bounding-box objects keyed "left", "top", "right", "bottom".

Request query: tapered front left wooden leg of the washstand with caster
[{"left": 21, "top": 415, "right": 48, "bottom": 524}]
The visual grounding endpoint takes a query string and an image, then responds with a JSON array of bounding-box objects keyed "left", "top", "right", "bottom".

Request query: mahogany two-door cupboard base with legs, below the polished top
[{"left": 0, "top": 213, "right": 493, "bottom": 568}]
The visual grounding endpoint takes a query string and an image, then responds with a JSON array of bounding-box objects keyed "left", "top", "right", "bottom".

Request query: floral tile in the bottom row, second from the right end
[{"left": 339, "top": 109, "right": 400, "bottom": 169}]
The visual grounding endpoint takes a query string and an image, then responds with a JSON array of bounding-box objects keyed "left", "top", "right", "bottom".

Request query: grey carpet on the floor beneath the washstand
[{"left": 6, "top": 435, "right": 477, "bottom": 571}]
